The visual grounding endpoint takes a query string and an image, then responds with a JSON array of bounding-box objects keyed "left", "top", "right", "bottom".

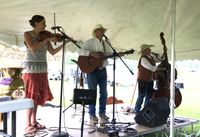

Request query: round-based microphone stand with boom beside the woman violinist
[{"left": 51, "top": 28, "right": 81, "bottom": 137}]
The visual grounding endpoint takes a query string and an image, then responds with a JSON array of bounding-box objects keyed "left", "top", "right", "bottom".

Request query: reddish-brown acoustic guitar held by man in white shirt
[{"left": 78, "top": 49, "right": 134, "bottom": 73}]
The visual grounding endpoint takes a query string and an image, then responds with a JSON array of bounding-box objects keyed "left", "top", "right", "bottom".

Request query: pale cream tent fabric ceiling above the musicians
[{"left": 0, "top": 0, "right": 200, "bottom": 60}]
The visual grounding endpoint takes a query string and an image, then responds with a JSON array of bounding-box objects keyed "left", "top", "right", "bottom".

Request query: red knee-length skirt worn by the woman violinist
[{"left": 22, "top": 73, "right": 53, "bottom": 105}]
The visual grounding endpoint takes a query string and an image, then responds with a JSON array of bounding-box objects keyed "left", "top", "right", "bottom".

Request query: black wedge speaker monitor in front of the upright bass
[{"left": 134, "top": 97, "right": 170, "bottom": 127}]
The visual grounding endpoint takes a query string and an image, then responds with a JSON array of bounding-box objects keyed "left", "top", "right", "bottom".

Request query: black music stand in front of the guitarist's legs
[{"left": 73, "top": 88, "right": 97, "bottom": 137}]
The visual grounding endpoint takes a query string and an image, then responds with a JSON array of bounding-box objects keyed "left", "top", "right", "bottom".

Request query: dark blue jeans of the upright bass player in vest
[{"left": 135, "top": 80, "right": 154, "bottom": 113}]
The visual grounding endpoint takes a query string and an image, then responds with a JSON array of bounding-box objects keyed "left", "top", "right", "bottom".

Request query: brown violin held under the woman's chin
[{"left": 40, "top": 30, "right": 62, "bottom": 42}]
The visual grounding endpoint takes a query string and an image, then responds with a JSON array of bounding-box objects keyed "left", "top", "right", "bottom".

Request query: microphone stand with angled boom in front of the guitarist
[{"left": 104, "top": 35, "right": 134, "bottom": 134}]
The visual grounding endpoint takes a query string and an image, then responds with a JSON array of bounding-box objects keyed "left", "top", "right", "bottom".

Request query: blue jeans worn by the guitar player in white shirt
[{"left": 87, "top": 68, "right": 108, "bottom": 116}]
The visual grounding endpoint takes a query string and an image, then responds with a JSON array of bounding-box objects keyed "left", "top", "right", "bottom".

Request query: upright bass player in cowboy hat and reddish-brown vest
[{"left": 135, "top": 44, "right": 164, "bottom": 114}]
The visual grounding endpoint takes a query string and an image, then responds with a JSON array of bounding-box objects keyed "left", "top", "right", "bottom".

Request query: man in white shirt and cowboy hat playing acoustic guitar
[{"left": 78, "top": 24, "right": 121, "bottom": 124}]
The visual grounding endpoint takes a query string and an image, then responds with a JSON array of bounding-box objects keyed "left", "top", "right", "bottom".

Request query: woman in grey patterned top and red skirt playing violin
[{"left": 22, "top": 15, "right": 69, "bottom": 133}]
